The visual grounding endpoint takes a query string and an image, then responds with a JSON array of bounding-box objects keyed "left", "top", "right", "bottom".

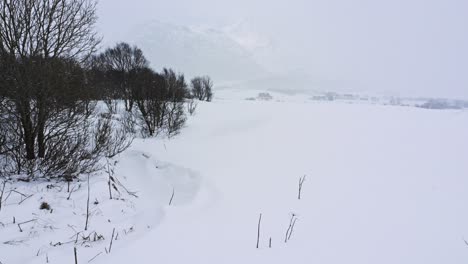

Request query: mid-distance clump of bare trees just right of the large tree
[{"left": 90, "top": 43, "right": 191, "bottom": 136}]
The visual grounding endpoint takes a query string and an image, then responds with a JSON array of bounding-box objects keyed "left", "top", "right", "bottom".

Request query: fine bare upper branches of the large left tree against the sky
[{"left": 0, "top": 0, "right": 100, "bottom": 60}]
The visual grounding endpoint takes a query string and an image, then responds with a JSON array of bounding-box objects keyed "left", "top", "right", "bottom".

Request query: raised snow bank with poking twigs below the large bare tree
[{"left": 0, "top": 151, "right": 201, "bottom": 264}]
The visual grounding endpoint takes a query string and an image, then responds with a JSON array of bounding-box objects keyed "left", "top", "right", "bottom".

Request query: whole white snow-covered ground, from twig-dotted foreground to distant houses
[{"left": 0, "top": 91, "right": 468, "bottom": 264}]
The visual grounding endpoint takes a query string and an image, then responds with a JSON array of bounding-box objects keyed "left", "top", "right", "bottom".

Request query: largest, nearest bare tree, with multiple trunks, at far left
[{"left": 0, "top": 0, "right": 100, "bottom": 179}]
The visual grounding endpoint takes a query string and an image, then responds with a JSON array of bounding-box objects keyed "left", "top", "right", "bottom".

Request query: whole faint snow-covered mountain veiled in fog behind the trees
[{"left": 121, "top": 20, "right": 362, "bottom": 92}]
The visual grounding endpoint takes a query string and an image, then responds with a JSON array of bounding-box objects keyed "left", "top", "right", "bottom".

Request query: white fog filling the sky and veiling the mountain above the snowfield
[{"left": 98, "top": 0, "right": 468, "bottom": 99}]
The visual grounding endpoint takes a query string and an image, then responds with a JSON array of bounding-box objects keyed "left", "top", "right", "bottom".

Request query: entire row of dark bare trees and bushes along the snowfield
[{"left": 0, "top": 0, "right": 213, "bottom": 181}]
